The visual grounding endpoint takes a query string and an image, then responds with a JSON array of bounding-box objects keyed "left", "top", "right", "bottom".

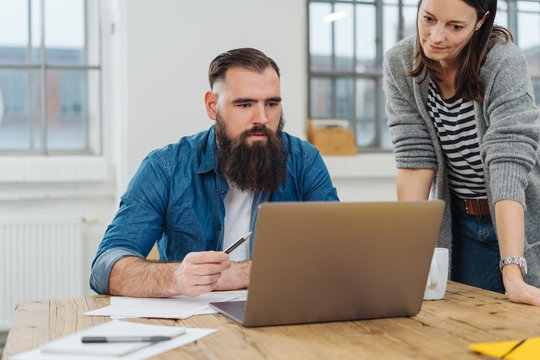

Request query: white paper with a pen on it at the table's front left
[{"left": 12, "top": 320, "right": 216, "bottom": 360}]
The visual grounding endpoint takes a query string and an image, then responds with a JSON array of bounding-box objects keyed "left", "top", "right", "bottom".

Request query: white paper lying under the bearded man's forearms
[{"left": 84, "top": 290, "right": 247, "bottom": 319}]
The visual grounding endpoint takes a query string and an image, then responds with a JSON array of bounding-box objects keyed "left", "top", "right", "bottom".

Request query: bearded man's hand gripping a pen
[{"left": 174, "top": 251, "right": 231, "bottom": 296}]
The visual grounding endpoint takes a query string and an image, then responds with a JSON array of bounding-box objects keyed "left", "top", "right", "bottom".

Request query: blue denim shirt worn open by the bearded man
[{"left": 90, "top": 126, "right": 338, "bottom": 294}]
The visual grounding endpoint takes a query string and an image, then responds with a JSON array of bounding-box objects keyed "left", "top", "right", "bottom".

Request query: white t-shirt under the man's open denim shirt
[{"left": 223, "top": 185, "right": 253, "bottom": 262}]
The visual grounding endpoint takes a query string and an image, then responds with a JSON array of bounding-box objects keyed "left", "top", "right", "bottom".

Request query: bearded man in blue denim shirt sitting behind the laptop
[{"left": 90, "top": 48, "right": 338, "bottom": 297}]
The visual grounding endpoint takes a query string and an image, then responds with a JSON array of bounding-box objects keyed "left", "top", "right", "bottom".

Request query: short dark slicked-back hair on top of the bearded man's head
[{"left": 208, "top": 48, "right": 279, "bottom": 89}]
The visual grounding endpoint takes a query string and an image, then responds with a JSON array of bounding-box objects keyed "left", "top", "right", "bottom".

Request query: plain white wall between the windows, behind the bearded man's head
[{"left": 120, "top": 0, "right": 307, "bottom": 190}]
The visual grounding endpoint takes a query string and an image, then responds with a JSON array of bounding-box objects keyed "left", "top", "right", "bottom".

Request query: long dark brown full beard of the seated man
[{"left": 216, "top": 113, "right": 287, "bottom": 192}]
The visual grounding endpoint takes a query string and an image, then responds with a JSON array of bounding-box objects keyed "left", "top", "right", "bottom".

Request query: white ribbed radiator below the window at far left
[{"left": 0, "top": 215, "right": 85, "bottom": 330}]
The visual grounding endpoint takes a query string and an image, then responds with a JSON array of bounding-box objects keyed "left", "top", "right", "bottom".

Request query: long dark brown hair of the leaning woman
[{"left": 410, "top": 0, "right": 513, "bottom": 101}]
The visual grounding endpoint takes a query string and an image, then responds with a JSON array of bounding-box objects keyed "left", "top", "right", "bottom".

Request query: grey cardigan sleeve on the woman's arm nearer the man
[{"left": 383, "top": 38, "right": 437, "bottom": 169}]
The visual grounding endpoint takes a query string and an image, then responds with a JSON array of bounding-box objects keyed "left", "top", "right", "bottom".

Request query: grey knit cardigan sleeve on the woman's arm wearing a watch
[{"left": 481, "top": 43, "right": 540, "bottom": 206}]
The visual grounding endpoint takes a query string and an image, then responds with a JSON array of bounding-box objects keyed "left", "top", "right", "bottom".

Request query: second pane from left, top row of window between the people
[{"left": 334, "top": 4, "right": 354, "bottom": 71}]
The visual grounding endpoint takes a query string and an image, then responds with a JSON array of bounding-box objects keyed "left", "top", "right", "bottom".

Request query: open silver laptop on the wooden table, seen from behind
[{"left": 210, "top": 201, "right": 444, "bottom": 327}]
